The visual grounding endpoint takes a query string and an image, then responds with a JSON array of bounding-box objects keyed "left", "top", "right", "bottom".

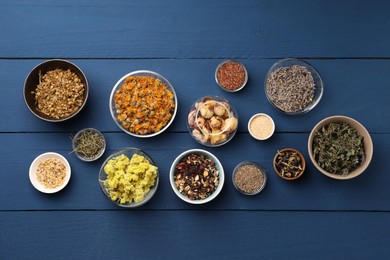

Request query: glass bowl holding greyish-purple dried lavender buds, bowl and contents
[{"left": 264, "top": 58, "right": 324, "bottom": 115}]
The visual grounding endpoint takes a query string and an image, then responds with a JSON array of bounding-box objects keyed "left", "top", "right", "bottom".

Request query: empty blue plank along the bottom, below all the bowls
[{"left": 0, "top": 210, "right": 390, "bottom": 259}]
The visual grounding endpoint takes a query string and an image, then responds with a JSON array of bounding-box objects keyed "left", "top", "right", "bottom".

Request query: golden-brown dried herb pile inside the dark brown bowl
[{"left": 33, "top": 69, "right": 85, "bottom": 119}]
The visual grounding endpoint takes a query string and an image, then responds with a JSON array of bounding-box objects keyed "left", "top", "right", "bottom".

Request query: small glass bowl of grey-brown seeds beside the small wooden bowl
[{"left": 233, "top": 164, "right": 265, "bottom": 194}]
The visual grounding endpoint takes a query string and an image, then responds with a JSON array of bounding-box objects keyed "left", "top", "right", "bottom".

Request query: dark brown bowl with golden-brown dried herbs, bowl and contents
[{"left": 23, "top": 59, "right": 89, "bottom": 122}]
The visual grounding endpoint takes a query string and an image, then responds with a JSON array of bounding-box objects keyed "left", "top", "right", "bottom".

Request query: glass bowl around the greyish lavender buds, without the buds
[{"left": 264, "top": 58, "right": 324, "bottom": 115}]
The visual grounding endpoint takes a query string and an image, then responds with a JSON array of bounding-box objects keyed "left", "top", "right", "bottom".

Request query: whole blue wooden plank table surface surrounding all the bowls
[{"left": 0, "top": 0, "right": 390, "bottom": 259}]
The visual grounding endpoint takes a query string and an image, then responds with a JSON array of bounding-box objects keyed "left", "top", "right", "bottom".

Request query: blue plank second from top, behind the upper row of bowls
[{"left": 0, "top": 59, "right": 390, "bottom": 133}]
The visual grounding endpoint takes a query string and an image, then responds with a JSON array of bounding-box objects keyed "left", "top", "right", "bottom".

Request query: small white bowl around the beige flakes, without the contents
[{"left": 29, "top": 152, "right": 71, "bottom": 193}]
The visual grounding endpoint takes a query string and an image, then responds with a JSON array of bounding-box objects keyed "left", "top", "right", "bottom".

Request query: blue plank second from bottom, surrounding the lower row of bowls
[{"left": 0, "top": 133, "right": 390, "bottom": 211}]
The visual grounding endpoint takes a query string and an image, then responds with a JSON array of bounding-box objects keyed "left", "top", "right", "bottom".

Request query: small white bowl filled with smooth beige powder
[{"left": 248, "top": 113, "right": 275, "bottom": 140}]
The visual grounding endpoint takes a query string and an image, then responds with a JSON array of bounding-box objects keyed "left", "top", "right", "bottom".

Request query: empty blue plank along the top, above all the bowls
[{"left": 0, "top": 0, "right": 390, "bottom": 59}]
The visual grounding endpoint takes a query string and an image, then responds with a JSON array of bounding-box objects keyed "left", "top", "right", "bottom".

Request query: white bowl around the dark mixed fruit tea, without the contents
[{"left": 169, "top": 149, "right": 225, "bottom": 204}]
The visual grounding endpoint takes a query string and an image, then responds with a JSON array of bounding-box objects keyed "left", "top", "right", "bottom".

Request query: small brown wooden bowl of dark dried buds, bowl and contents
[{"left": 273, "top": 148, "right": 306, "bottom": 181}]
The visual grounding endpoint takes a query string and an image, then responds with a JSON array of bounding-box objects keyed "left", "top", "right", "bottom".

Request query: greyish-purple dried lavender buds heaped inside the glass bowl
[{"left": 266, "top": 65, "right": 315, "bottom": 113}]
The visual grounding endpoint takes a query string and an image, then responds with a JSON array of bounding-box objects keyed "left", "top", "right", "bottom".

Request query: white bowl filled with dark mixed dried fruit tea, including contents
[{"left": 169, "top": 149, "right": 225, "bottom": 204}]
